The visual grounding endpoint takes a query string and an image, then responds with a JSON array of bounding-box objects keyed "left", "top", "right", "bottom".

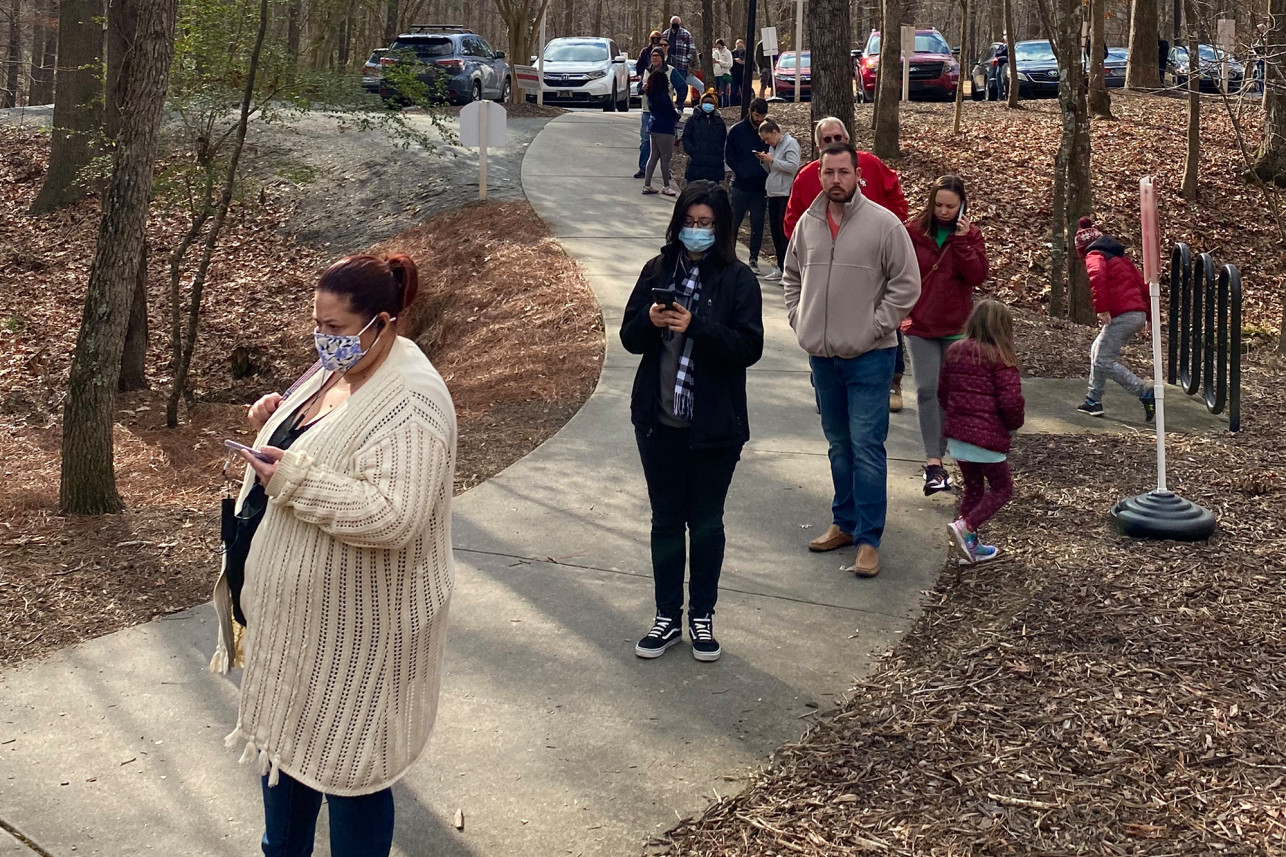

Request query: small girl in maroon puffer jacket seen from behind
[{"left": 937, "top": 300, "right": 1024, "bottom": 564}]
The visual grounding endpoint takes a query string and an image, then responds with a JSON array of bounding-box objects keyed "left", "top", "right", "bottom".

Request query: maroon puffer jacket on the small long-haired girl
[{"left": 937, "top": 340, "right": 1024, "bottom": 453}]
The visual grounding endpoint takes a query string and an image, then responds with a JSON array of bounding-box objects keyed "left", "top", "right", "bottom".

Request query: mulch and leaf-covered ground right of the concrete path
[{"left": 653, "top": 98, "right": 1286, "bottom": 857}]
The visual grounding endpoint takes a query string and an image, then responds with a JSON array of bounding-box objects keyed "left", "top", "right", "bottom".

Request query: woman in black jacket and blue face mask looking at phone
[{"left": 621, "top": 181, "right": 764, "bottom": 661}]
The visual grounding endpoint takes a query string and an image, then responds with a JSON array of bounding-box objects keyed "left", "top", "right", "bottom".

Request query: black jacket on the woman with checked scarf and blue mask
[{"left": 621, "top": 246, "right": 764, "bottom": 449}]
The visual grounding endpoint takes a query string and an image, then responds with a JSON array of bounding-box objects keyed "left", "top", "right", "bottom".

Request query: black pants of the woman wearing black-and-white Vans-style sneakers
[{"left": 634, "top": 425, "right": 741, "bottom": 619}]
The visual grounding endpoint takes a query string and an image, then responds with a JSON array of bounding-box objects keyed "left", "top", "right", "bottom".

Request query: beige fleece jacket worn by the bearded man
[{"left": 782, "top": 193, "right": 919, "bottom": 358}]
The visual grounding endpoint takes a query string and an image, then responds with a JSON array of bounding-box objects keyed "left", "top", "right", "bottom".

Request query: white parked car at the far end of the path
[{"left": 527, "top": 36, "right": 630, "bottom": 113}]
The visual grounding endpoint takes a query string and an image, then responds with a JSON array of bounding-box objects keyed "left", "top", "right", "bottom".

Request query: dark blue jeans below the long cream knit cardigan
[{"left": 264, "top": 773, "right": 394, "bottom": 857}]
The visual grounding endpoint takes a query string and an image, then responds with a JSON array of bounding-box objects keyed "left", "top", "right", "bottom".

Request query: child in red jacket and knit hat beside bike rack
[{"left": 1076, "top": 217, "right": 1156, "bottom": 422}]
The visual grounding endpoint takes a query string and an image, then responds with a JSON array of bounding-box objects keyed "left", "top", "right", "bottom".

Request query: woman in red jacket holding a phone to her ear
[{"left": 901, "top": 175, "right": 986, "bottom": 497}]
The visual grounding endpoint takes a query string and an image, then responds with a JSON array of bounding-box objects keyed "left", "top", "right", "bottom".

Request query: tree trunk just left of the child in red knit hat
[{"left": 1040, "top": 0, "right": 1094, "bottom": 324}]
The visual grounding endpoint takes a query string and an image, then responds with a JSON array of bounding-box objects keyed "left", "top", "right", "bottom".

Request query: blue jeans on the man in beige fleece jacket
[{"left": 809, "top": 347, "right": 898, "bottom": 547}]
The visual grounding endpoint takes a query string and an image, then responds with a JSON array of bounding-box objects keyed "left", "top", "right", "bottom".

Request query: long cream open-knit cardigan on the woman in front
[{"left": 211, "top": 338, "right": 455, "bottom": 795}]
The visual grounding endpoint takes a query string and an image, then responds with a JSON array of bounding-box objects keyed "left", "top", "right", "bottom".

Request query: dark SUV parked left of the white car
[{"left": 379, "top": 24, "right": 512, "bottom": 104}]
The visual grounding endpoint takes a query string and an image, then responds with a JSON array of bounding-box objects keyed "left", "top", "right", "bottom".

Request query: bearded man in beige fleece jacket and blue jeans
[{"left": 782, "top": 143, "right": 919, "bottom": 578}]
